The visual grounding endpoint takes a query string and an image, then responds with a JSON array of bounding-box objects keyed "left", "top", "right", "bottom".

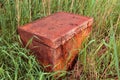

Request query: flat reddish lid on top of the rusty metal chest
[{"left": 18, "top": 12, "right": 93, "bottom": 48}]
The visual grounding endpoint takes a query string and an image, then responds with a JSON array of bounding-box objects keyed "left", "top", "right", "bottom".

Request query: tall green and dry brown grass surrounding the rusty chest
[{"left": 0, "top": 0, "right": 120, "bottom": 80}]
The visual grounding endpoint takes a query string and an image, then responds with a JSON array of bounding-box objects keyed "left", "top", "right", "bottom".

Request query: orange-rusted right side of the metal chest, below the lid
[{"left": 53, "top": 26, "right": 92, "bottom": 71}]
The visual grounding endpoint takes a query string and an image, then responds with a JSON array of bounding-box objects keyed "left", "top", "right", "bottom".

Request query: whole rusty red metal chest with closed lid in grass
[{"left": 18, "top": 12, "right": 93, "bottom": 71}]
